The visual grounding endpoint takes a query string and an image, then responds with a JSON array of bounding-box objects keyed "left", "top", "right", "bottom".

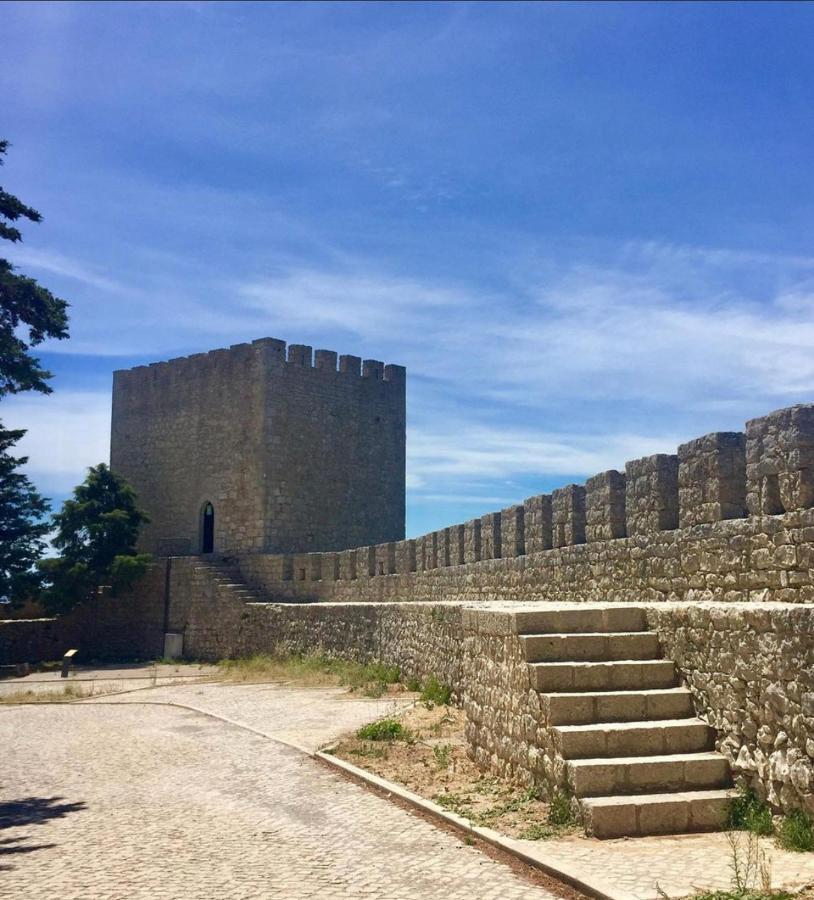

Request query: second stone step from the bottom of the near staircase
[{"left": 566, "top": 752, "right": 732, "bottom": 797}]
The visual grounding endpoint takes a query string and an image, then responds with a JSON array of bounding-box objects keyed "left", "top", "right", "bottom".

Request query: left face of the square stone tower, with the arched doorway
[{"left": 110, "top": 344, "right": 267, "bottom": 555}]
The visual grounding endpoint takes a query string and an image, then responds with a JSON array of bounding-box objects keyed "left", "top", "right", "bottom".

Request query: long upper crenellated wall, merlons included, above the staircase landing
[{"left": 226, "top": 406, "right": 814, "bottom": 603}]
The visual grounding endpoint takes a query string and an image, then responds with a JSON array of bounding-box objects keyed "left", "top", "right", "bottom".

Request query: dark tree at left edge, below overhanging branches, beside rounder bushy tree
[{"left": 0, "top": 423, "right": 50, "bottom": 602}]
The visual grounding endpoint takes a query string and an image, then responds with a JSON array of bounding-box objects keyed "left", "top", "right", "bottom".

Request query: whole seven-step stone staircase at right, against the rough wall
[{"left": 515, "top": 605, "right": 731, "bottom": 838}]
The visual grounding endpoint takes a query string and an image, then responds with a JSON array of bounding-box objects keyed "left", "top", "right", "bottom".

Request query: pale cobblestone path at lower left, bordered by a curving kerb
[{"left": 0, "top": 685, "right": 554, "bottom": 900}]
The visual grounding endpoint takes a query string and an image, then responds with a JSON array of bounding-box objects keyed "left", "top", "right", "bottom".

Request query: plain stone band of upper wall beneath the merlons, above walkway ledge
[{"left": 238, "top": 509, "right": 814, "bottom": 603}]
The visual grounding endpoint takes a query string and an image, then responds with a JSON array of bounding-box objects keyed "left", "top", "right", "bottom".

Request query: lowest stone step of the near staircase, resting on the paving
[{"left": 580, "top": 790, "right": 731, "bottom": 838}]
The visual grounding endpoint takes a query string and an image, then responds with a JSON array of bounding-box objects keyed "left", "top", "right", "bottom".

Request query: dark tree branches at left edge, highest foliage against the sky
[{"left": 0, "top": 140, "right": 68, "bottom": 397}]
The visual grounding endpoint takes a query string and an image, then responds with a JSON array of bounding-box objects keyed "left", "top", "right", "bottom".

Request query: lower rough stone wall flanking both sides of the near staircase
[{"left": 0, "top": 558, "right": 814, "bottom": 811}]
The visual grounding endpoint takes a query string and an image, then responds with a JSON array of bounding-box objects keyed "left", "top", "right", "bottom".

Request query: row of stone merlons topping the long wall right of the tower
[{"left": 239, "top": 404, "right": 814, "bottom": 580}]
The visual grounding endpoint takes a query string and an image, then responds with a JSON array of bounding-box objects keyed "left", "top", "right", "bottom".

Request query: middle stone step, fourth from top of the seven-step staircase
[{"left": 540, "top": 687, "right": 693, "bottom": 725}]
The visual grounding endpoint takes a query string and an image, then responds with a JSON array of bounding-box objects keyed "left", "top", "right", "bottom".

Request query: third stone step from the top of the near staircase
[{"left": 529, "top": 659, "right": 676, "bottom": 693}]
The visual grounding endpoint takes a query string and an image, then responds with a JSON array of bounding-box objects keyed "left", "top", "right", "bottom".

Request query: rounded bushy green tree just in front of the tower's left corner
[{"left": 39, "top": 463, "right": 150, "bottom": 613}]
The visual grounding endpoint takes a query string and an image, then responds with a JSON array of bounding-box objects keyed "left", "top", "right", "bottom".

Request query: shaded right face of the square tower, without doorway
[{"left": 265, "top": 347, "right": 406, "bottom": 553}]
